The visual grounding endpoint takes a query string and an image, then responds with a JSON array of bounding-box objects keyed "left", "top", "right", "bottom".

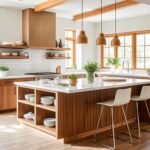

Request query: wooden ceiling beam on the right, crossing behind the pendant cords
[{"left": 73, "top": 0, "right": 140, "bottom": 21}]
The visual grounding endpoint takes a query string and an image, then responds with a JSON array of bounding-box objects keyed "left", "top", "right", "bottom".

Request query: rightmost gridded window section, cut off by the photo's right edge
[{"left": 136, "top": 34, "right": 150, "bottom": 69}]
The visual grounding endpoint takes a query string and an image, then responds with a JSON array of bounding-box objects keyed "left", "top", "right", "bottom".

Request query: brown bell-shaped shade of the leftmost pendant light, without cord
[{"left": 77, "top": 30, "right": 88, "bottom": 44}]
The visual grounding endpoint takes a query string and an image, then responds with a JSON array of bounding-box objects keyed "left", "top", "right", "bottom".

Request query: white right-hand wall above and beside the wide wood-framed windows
[{"left": 96, "top": 16, "right": 150, "bottom": 66}]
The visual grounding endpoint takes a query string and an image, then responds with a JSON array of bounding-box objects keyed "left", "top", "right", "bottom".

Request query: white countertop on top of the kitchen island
[{"left": 15, "top": 77, "right": 150, "bottom": 93}]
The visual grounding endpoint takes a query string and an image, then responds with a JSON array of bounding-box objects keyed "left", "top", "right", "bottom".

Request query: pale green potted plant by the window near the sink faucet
[{"left": 107, "top": 57, "right": 121, "bottom": 70}]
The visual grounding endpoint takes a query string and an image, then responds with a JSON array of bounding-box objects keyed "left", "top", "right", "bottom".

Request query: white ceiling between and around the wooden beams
[{"left": 0, "top": 0, "right": 150, "bottom": 22}]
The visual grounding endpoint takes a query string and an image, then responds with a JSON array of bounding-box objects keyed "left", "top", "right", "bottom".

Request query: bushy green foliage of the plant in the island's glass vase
[{"left": 84, "top": 61, "right": 99, "bottom": 73}]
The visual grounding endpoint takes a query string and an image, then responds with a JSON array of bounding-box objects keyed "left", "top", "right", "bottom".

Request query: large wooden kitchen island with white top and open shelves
[{"left": 16, "top": 77, "right": 150, "bottom": 143}]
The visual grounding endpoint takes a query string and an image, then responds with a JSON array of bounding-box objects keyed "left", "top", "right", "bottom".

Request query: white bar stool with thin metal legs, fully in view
[{"left": 94, "top": 88, "right": 133, "bottom": 149}]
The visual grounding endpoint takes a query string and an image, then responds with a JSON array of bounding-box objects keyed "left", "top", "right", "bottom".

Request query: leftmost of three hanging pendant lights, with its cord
[{"left": 77, "top": 0, "right": 88, "bottom": 44}]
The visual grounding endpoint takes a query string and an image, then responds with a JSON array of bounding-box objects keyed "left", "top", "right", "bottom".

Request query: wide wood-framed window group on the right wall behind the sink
[{"left": 101, "top": 31, "right": 150, "bottom": 69}]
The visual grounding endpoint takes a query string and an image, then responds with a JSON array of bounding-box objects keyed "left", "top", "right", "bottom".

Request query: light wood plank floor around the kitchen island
[{"left": 0, "top": 113, "right": 150, "bottom": 150}]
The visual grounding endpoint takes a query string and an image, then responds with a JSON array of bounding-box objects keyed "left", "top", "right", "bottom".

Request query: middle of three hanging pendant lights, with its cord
[{"left": 96, "top": 0, "right": 106, "bottom": 45}]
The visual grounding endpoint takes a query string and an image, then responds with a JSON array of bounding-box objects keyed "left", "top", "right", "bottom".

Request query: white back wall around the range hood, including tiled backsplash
[{"left": 0, "top": 7, "right": 96, "bottom": 74}]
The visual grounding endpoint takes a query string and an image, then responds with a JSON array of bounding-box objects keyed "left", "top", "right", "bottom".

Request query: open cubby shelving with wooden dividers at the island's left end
[{"left": 17, "top": 86, "right": 57, "bottom": 137}]
